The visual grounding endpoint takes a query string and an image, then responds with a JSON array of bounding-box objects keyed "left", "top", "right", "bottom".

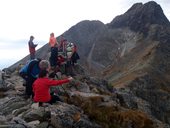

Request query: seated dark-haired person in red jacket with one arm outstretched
[{"left": 33, "top": 70, "right": 73, "bottom": 106}]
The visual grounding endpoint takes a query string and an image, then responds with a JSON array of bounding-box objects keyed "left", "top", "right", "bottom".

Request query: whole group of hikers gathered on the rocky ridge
[{"left": 19, "top": 33, "right": 80, "bottom": 105}]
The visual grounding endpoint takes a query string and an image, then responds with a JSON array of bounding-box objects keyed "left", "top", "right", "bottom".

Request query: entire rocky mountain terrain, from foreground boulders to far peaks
[{"left": 0, "top": 1, "right": 170, "bottom": 128}]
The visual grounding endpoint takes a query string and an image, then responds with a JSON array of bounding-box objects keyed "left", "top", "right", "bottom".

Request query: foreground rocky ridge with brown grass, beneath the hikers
[{"left": 0, "top": 65, "right": 168, "bottom": 128}]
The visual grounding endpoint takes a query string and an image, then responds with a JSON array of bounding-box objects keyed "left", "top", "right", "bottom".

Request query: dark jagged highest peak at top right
[{"left": 109, "top": 1, "right": 170, "bottom": 32}]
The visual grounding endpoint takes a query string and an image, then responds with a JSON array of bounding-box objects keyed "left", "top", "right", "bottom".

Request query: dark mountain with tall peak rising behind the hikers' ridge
[{"left": 10, "top": 1, "right": 170, "bottom": 125}]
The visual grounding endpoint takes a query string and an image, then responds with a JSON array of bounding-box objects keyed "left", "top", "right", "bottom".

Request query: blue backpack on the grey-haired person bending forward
[{"left": 19, "top": 59, "right": 40, "bottom": 80}]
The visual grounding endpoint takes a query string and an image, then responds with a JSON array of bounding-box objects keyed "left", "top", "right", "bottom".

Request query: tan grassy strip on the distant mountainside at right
[{"left": 103, "top": 42, "right": 158, "bottom": 78}]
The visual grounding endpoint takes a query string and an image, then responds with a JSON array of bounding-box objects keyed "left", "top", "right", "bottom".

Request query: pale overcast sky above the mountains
[{"left": 0, "top": 0, "right": 170, "bottom": 69}]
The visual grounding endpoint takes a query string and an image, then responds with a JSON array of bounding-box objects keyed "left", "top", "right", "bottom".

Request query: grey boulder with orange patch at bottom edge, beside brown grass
[{"left": 51, "top": 103, "right": 99, "bottom": 128}]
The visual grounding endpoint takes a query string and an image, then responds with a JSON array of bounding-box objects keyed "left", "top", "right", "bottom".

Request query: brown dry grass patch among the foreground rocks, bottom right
[{"left": 68, "top": 96, "right": 153, "bottom": 128}]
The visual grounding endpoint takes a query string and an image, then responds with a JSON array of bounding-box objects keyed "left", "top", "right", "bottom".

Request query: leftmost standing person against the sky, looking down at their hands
[{"left": 28, "top": 36, "right": 38, "bottom": 60}]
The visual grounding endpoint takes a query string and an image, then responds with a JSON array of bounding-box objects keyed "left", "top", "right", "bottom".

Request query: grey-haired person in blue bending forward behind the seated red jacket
[{"left": 19, "top": 59, "right": 50, "bottom": 98}]
